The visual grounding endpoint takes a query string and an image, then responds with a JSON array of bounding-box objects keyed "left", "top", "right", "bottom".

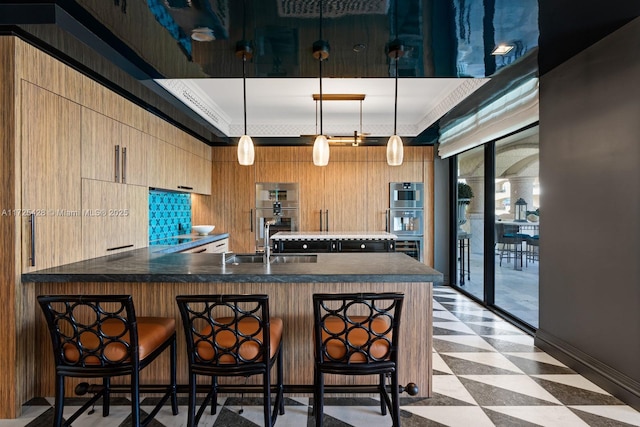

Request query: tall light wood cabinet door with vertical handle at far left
[{"left": 20, "top": 81, "right": 82, "bottom": 272}]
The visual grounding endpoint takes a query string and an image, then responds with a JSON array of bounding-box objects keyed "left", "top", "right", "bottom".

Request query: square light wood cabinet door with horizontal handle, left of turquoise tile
[{"left": 82, "top": 179, "right": 149, "bottom": 259}]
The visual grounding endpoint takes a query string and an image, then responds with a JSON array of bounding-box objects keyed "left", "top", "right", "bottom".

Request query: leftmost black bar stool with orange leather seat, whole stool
[{"left": 38, "top": 295, "right": 178, "bottom": 427}]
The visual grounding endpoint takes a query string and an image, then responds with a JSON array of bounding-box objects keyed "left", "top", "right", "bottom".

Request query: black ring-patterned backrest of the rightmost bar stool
[{"left": 313, "top": 293, "right": 404, "bottom": 364}]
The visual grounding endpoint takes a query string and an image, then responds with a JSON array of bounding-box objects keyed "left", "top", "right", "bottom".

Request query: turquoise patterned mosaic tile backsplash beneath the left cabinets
[{"left": 149, "top": 190, "right": 191, "bottom": 245}]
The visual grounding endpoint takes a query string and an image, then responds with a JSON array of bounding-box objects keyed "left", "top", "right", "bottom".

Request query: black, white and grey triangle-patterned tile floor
[{"left": 0, "top": 287, "right": 640, "bottom": 427}]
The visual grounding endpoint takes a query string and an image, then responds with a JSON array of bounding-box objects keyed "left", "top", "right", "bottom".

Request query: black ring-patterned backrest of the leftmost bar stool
[{"left": 38, "top": 295, "right": 139, "bottom": 375}]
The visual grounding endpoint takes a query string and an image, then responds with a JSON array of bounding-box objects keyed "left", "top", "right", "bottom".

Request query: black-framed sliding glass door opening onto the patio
[{"left": 451, "top": 126, "right": 540, "bottom": 329}]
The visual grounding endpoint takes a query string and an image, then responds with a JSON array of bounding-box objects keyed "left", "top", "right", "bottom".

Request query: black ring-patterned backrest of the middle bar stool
[{"left": 176, "top": 295, "right": 270, "bottom": 371}]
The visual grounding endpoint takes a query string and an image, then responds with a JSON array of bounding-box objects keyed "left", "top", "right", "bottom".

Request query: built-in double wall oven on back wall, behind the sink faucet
[{"left": 255, "top": 182, "right": 300, "bottom": 251}]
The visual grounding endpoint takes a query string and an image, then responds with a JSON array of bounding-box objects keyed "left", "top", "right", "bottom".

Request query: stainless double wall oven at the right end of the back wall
[{"left": 387, "top": 182, "right": 424, "bottom": 262}]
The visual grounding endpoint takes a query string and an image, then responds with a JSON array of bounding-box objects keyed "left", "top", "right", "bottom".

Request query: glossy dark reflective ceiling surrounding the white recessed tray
[{"left": 0, "top": 0, "right": 640, "bottom": 144}]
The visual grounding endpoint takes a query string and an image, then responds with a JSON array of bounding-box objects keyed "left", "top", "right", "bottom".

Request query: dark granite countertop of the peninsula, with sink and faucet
[{"left": 22, "top": 248, "right": 443, "bottom": 283}]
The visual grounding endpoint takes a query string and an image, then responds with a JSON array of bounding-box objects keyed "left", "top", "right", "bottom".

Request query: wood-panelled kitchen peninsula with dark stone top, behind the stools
[{"left": 22, "top": 248, "right": 442, "bottom": 396}]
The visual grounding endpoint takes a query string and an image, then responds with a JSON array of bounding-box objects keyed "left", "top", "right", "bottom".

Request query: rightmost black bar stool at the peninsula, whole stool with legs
[{"left": 313, "top": 293, "right": 404, "bottom": 427}]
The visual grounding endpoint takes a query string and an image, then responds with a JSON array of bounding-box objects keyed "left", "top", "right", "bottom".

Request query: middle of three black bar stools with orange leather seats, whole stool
[{"left": 176, "top": 295, "right": 284, "bottom": 427}]
